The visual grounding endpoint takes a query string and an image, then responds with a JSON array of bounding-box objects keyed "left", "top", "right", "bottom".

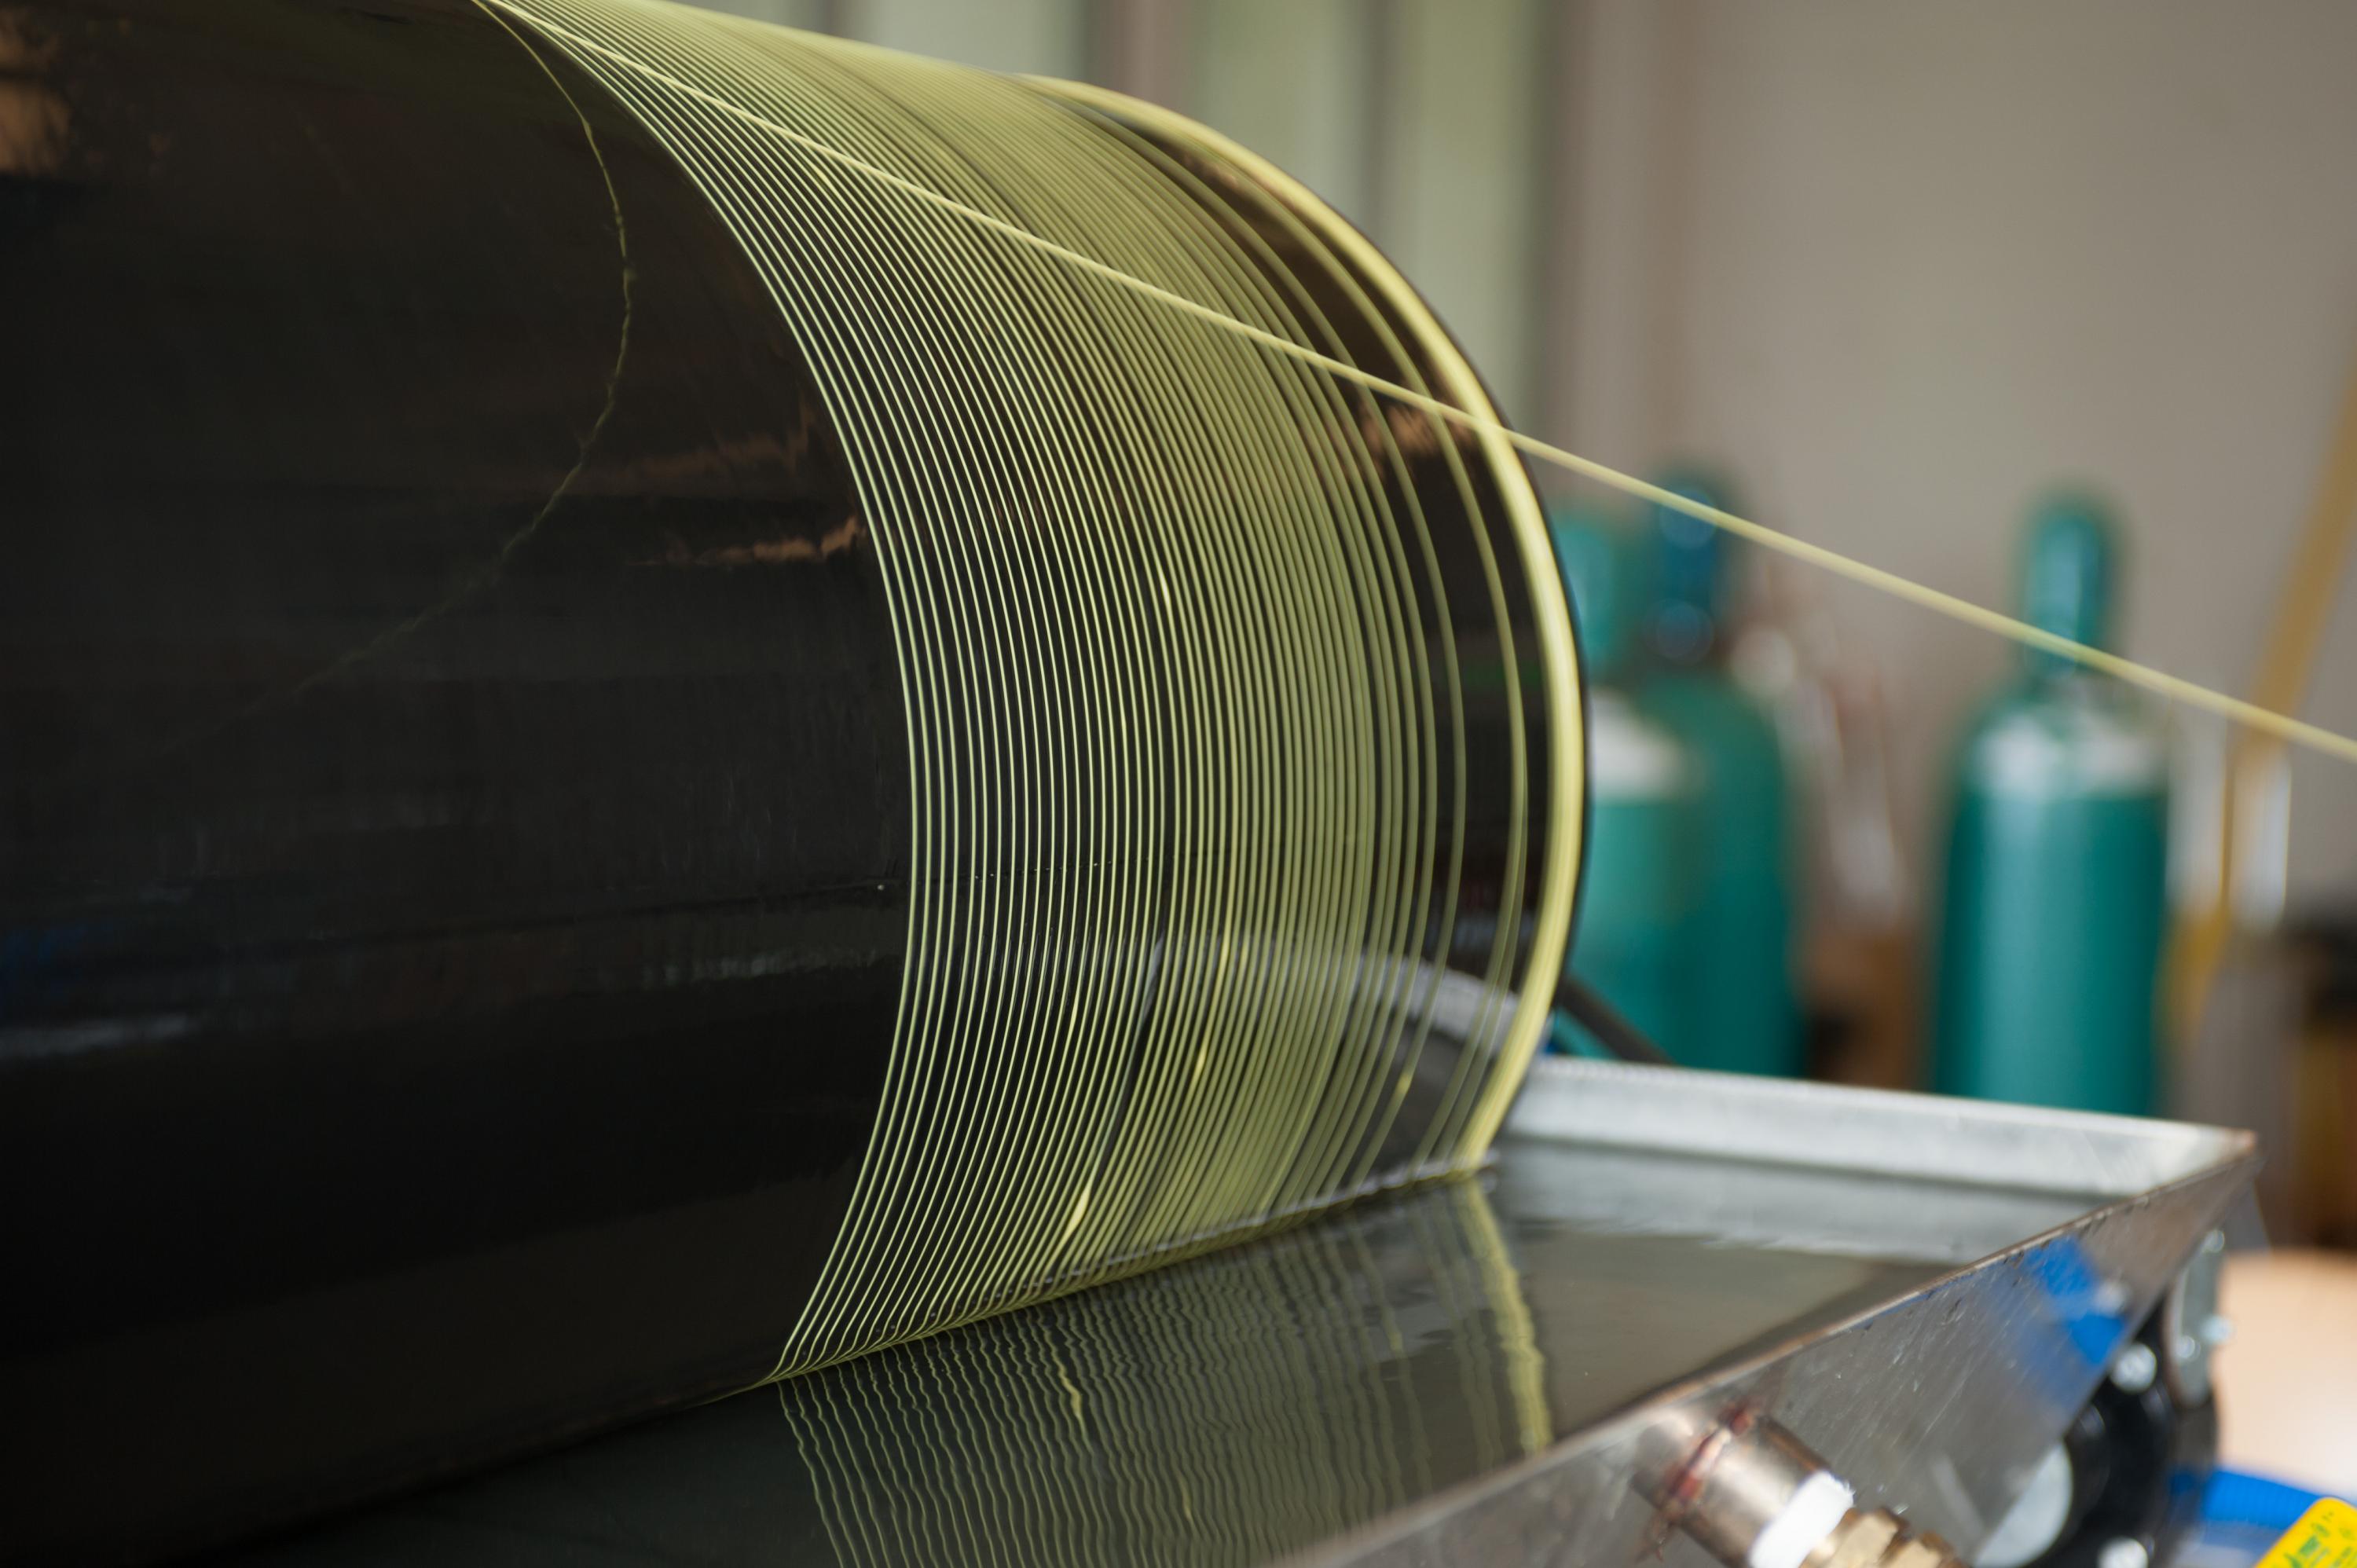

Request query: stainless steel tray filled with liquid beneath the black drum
[{"left": 248, "top": 1061, "right": 2256, "bottom": 1568}]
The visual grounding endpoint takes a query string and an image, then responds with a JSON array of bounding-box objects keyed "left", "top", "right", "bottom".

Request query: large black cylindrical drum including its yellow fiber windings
[{"left": 0, "top": 0, "right": 1582, "bottom": 1556}]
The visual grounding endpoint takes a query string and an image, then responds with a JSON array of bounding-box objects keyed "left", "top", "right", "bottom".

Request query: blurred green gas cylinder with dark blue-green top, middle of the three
[{"left": 1638, "top": 469, "right": 1805, "bottom": 1075}]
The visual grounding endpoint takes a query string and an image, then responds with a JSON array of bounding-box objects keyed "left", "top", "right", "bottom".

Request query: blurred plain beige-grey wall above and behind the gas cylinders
[{"left": 1553, "top": 0, "right": 2357, "bottom": 894}]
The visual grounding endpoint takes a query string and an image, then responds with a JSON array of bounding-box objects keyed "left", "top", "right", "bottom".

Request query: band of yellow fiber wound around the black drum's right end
[{"left": 478, "top": 0, "right": 1579, "bottom": 1368}]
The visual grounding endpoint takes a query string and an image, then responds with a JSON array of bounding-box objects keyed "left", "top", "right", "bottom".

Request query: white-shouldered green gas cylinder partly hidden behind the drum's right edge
[{"left": 1549, "top": 507, "right": 1699, "bottom": 1054}]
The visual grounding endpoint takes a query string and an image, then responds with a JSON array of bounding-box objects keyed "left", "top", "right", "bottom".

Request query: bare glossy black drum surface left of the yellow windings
[{"left": 0, "top": 0, "right": 907, "bottom": 1559}]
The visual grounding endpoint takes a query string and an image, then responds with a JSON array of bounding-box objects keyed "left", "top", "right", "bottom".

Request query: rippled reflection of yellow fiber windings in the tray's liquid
[{"left": 778, "top": 1181, "right": 1551, "bottom": 1568}]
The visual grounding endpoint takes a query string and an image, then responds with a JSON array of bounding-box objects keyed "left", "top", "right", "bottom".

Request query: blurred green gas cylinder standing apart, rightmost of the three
[{"left": 1933, "top": 495, "right": 2168, "bottom": 1113}]
